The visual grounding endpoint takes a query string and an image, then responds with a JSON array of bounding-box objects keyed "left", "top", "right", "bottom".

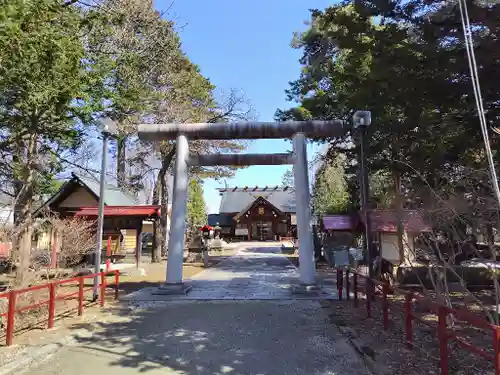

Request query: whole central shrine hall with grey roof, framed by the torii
[{"left": 208, "top": 186, "right": 297, "bottom": 241}]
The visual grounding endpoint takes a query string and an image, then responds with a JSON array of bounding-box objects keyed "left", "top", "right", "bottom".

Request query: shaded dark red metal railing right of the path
[{"left": 337, "top": 269, "right": 500, "bottom": 375}]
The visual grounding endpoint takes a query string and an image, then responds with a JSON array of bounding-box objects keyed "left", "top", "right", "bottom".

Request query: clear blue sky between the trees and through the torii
[{"left": 155, "top": 0, "right": 333, "bottom": 213}]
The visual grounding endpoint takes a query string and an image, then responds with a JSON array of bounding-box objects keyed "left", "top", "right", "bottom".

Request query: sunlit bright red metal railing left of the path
[{"left": 0, "top": 270, "right": 120, "bottom": 346}]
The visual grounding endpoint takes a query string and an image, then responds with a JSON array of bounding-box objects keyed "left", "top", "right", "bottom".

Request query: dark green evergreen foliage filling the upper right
[{"left": 276, "top": 1, "right": 500, "bottom": 210}]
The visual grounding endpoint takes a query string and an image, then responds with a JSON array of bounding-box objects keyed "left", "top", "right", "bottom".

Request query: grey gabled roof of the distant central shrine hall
[{"left": 218, "top": 186, "right": 296, "bottom": 213}]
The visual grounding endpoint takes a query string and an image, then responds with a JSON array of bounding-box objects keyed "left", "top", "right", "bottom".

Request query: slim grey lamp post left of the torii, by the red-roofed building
[{"left": 94, "top": 118, "right": 117, "bottom": 299}]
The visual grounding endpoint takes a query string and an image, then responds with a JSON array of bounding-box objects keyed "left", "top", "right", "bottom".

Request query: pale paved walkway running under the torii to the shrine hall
[{"left": 127, "top": 243, "right": 338, "bottom": 305}]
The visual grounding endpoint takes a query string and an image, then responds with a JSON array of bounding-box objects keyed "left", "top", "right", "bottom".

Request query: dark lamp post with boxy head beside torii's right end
[{"left": 352, "top": 111, "right": 373, "bottom": 298}]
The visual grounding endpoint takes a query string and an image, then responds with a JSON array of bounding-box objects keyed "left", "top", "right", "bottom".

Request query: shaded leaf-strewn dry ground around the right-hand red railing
[{"left": 319, "top": 268, "right": 493, "bottom": 375}]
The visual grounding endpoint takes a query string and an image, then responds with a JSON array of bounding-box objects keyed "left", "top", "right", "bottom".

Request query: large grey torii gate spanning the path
[{"left": 138, "top": 111, "right": 371, "bottom": 294}]
